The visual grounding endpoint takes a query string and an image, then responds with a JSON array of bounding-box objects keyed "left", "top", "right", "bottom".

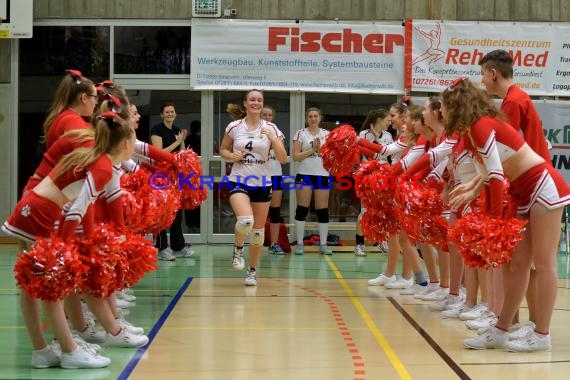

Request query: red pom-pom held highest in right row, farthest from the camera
[{"left": 320, "top": 124, "right": 360, "bottom": 175}]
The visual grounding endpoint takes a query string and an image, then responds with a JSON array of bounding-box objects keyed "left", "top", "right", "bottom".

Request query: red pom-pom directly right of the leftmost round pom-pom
[{"left": 78, "top": 224, "right": 128, "bottom": 298}]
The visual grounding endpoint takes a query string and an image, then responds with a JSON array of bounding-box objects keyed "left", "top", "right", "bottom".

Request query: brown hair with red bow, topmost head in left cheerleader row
[{"left": 42, "top": 73, "right": 95, "bottom": 141}]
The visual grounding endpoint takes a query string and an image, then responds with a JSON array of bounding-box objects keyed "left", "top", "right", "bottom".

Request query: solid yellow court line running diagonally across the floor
[{"left": 325, "top": 256, "right": 412, "bottom": 380}]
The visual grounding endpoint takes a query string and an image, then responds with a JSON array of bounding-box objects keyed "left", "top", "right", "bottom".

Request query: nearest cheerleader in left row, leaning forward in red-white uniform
[{"left": 2, "top": 114, "right": 134, "bottom": 368}]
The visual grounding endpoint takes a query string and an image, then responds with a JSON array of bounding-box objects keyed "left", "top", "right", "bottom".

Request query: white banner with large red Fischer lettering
[{"left": 190, "top": 18, "right": 404, "bottom": 94}]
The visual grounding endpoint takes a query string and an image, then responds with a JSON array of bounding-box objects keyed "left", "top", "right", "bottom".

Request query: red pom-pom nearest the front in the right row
[{"left": 449, "top": 214, "right": 527, "bottom": 268}]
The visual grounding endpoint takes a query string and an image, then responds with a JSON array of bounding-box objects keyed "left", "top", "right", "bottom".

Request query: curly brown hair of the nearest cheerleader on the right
[{"left": 441, "top": 79, "right": 500, "bottom": 135}]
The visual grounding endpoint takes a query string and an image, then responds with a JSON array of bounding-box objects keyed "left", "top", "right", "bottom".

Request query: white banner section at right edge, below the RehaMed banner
[{"left": 533, "top": 100, "right": 570, "bottom": 183}]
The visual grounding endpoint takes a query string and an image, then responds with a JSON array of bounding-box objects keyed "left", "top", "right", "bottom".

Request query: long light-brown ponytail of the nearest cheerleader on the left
[{"left": 55, "top": 115, "right": 135, "bottom": 179}]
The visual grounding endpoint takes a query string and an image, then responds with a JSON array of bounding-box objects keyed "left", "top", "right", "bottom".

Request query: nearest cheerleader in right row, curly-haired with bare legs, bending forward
[{"left": 442, "top": 78, "right": 570, "bottom": 351}]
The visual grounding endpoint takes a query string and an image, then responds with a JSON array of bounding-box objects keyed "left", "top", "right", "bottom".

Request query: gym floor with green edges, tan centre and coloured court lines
[{"left": 0, "top": 244, "right": 570, "bottom": 380}]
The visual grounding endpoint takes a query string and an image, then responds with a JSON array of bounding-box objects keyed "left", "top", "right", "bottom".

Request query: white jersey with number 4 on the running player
[{"left": 226, "top": 119, "right": 283, "bottom": 187}]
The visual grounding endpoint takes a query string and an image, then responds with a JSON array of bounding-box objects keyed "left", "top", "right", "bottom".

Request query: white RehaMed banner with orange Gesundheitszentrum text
[{"left": 405, "top": 20, "right": 570, "bottom": 96}]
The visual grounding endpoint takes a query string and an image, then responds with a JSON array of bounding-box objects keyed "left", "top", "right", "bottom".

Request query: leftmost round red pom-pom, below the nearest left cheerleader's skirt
[{"left": 14, "top": 236, "right": 87, "bottom": 302}]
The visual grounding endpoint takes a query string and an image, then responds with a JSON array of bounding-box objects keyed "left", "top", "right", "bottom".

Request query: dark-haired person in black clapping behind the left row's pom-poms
[{"left": 150, "top": 103, "right": 194, "bottom": 261}]
